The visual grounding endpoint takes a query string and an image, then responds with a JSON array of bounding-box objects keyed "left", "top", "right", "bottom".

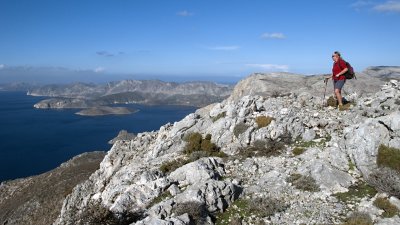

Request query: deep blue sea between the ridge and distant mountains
[{"left": 0, "top": 91, "right": 196, "bottom": 182}]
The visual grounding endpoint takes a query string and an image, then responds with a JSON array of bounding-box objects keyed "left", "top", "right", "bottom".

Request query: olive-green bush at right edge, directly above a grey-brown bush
[{"left": 376, "top": 145, "right": 400, "bottom": 172}]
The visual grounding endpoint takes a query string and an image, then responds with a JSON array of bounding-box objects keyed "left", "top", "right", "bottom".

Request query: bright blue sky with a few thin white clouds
[{"left": 0, "top": 0, "right": 400, "bottom": 81}]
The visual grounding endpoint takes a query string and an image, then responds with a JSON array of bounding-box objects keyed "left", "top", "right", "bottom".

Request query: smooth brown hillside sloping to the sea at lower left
[{"left": 0, "top": 152, "right": 105, "bottom": 225}]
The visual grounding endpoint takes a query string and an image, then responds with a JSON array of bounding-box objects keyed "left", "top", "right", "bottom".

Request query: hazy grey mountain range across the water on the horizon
[{"left": 27, "top": 80, "right": 233, "bottom": 108}]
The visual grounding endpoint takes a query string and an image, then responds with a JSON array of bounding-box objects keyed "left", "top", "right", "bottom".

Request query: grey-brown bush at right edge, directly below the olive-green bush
[{"left": 367, "top": 167, "right": 400, "bottom": 198}]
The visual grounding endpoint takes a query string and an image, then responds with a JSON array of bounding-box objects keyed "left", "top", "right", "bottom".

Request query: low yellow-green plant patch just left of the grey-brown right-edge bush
[{"left": 334, "top": 182, "right": 377, "bottom": 202}]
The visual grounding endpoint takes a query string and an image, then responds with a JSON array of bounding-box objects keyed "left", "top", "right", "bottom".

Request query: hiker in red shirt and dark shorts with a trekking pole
[{"left": 325, "top": 51, "right": 348, "bottom": 109}]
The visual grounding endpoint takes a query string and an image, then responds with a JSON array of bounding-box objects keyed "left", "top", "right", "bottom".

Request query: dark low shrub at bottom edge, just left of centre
[{"left": 173, "top": 201, "right": 209, "bottom": 224}]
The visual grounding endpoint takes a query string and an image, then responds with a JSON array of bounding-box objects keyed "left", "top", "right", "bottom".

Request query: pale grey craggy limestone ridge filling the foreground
[{"left": 55, "top": 74, "right": 400, "bottom": 224}]
